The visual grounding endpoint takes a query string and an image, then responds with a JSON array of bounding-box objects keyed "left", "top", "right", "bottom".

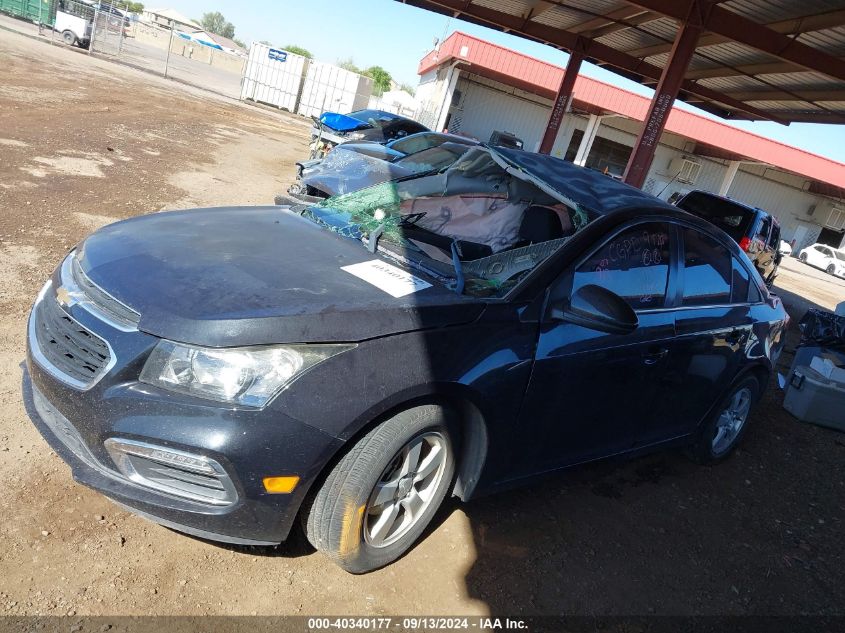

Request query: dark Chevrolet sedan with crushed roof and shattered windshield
[{"left": 24, "top": 146, "right": 787, "bottom": 573}]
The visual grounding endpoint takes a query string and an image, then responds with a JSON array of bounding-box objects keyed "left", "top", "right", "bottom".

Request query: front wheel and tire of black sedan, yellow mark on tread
[{"left": 302, "top": 405, "right": 455, "bottom": 574}]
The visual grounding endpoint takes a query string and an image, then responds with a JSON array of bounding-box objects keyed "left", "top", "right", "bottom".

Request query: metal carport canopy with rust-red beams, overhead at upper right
[{"left": 398, "top": 0, "right": 845, "bottom": 186}]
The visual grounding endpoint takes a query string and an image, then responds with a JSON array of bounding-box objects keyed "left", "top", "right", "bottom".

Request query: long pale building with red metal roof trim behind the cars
[{"left": 417, "top": 32, "right": 845, "bottom": 247}]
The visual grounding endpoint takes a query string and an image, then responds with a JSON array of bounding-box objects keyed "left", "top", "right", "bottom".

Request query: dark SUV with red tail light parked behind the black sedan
[{"left": 675, "top": 191, "right": 783, "bottom": 286}]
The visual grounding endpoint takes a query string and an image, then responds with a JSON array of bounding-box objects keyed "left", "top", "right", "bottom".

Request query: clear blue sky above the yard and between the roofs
[{"left": 166, "top": 0, "right": 845, "bottom": 163}]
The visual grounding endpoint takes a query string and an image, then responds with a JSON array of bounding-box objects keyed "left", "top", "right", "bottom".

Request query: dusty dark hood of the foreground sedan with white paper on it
[{"left": 77, "top": 207, "right": 483, "bottom": 346}]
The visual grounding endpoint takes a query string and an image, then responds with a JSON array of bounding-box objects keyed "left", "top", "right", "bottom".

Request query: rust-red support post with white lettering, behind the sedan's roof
[{"left": 623, "top": 14, "right": 702, "bottom": 187}]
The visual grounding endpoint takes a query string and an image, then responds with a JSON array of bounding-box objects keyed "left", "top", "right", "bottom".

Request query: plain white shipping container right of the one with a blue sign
[{"left": 296, "top": 62, "right": 373, "bottom": 116}]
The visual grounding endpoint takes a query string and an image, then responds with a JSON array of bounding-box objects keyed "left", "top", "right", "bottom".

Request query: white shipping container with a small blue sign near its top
[{"left": 241, "top": 44, "right": 309, "bottom": 112}]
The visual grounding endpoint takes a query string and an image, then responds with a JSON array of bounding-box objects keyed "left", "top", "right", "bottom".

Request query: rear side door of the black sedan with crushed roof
[{"left": 646, "top": 226, "right": 762, "bottom": 439}]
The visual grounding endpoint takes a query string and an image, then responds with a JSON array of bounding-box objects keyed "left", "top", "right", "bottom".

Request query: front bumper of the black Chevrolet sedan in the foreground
[{"left": 22, "top": 278, "right": 342, "bottom": 545}]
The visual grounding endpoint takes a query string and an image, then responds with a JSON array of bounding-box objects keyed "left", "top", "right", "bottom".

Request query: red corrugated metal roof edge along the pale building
[{"left": 418, "top": 32, "right": 845, "bottom": 189}]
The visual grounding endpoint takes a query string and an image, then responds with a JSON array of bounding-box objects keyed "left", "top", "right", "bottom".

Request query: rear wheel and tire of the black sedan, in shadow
[{"left": 689, "top": 376, "right": 762, "bottom": 464}]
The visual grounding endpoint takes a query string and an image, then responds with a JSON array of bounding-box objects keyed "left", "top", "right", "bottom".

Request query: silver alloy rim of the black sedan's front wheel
[{"left": 364, "top": 431, "right": 449, "bottom": 547}]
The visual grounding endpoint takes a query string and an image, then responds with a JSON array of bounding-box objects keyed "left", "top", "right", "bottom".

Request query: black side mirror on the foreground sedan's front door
[{"left": 550, "top": 284, "right": 639, "bottom": 334}]
